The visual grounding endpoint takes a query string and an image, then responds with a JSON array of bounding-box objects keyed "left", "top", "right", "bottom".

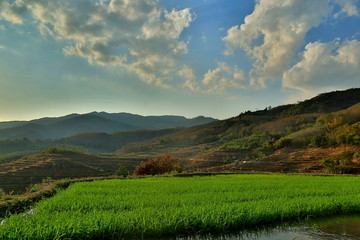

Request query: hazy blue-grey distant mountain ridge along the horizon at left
[{"left": 0, "top": 112, "right": 217, "bottom": 140}]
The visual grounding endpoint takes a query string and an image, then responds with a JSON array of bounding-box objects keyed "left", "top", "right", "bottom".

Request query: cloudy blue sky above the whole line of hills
[{"left": 0, "top": 0, "right": 360, "bottom": 121}]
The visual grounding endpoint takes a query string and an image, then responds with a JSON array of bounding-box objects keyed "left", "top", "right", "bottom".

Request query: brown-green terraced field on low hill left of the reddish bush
[{"left": 0, "top": 154, "right": 146, "bottom": 193}]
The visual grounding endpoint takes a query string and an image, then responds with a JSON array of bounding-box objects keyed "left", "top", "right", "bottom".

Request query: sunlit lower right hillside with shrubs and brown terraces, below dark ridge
[{"left": 189, "top": 103, "right": 360, "bottom": 174}]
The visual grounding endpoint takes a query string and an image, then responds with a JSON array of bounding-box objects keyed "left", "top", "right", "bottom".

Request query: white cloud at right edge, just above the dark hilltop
[{"left": 283, "top": 40, "right": 360, "bottom": 94}]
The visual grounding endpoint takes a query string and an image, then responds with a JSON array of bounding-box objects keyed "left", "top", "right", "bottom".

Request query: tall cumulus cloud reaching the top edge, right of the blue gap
[{"left": 223, "top": 0, "right": 357, "bottom": 87}]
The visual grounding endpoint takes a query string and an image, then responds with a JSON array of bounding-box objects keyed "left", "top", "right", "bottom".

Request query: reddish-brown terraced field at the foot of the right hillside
[{"left": 200, "top": 146, "right": 360, "bottom": 174}]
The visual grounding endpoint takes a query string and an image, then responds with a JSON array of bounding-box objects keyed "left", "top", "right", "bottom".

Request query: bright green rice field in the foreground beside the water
[{"left": 0, "top": 175, "right": 360, "bottom": 239}]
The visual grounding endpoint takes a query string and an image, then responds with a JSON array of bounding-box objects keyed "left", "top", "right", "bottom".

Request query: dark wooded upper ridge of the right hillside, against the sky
[{"left": 119, "top": 89, "right": 360, "bottom": 153}]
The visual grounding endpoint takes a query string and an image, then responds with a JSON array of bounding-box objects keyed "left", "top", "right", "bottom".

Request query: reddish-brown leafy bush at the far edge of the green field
[{"left": 134, "top": 153, "right": 181, "bottom": 176}]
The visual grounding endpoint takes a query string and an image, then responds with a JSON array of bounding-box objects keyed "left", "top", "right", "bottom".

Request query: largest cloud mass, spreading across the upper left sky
[{"left": 0, "top": 0, "right": 193, "bottom": 86}]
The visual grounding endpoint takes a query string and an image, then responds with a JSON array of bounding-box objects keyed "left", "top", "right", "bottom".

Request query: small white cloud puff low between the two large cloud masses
[{"left": 202, "top": 62, "right": 245, "bottom": 93}]
